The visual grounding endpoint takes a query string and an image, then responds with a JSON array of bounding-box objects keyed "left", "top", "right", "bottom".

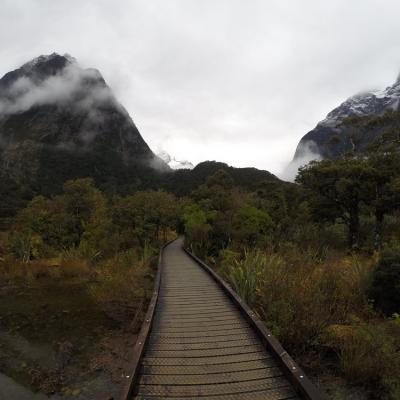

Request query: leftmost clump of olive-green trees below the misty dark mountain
[{"left": 11, "top": 179, "right": 114, "bottom": 261}]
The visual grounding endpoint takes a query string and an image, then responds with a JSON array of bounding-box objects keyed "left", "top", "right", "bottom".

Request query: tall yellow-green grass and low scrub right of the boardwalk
[{"left": 218, "top": 247, "right": 400, "bottom": 400}]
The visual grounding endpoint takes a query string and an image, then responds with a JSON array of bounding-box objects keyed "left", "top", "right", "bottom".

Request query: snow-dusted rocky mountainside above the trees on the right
[{"left": 294, "top": 76, "right": 400, "bottom": 161}]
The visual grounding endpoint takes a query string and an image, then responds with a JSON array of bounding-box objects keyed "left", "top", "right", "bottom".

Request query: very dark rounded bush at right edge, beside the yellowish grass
[{"left": 370, "top": 249, "right": 400, "bottom": 316}]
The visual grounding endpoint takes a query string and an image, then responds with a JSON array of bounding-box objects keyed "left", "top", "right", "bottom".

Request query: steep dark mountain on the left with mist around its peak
[{"left": 0, "top": 53, "right": 169, "bottom": 192}]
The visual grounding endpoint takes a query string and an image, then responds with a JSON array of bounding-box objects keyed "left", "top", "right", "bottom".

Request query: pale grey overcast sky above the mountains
[{"left": 0, "top": 0, "right": 400, "bottom": 175}]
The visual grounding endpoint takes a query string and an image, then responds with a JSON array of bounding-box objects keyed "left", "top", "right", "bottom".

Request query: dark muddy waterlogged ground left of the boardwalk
[{"left": 0, "top": 278, "right": 144, "bottom": 400}]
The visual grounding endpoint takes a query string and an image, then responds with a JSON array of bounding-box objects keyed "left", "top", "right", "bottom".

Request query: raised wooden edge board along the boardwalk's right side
[{"left": 183, "top": 248, "right": 326, "bottom": 400}]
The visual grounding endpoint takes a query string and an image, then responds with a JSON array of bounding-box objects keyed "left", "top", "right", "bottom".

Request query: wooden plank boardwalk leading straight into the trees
[{"left": 130, "top": 240, "right": 324, "bottom": 400}]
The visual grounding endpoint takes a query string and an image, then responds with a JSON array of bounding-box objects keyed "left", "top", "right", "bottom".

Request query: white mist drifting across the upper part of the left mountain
[{"left": 0, "top": 56, "right": 122, "bottom": 150}]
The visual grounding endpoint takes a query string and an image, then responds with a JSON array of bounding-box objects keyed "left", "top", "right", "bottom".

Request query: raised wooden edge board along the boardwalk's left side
[{"left": 121, "top": 240, "right": 174, "bottom": 400}]
